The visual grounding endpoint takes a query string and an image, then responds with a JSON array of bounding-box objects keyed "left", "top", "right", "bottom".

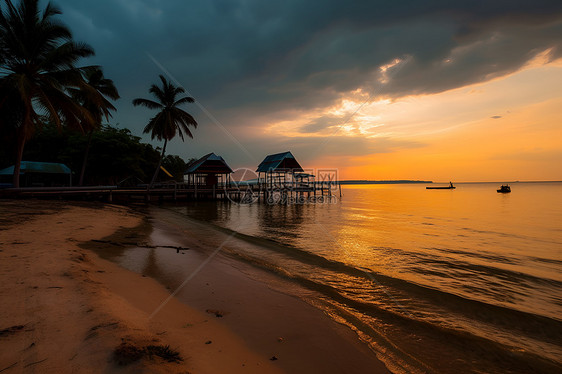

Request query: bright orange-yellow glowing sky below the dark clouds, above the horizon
[{"left": 265, "top": 52, "right": 562, "bottom": 182}]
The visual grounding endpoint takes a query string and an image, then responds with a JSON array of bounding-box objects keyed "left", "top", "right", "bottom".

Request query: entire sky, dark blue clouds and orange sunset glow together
[{"left": 50, "top": 0, "right": 562, "bottom": 181}]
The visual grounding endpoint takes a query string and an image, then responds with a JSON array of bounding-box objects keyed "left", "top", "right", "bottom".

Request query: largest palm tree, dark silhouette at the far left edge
[{"left": 0, "top": 0, "right": 94, "bottom": 187}]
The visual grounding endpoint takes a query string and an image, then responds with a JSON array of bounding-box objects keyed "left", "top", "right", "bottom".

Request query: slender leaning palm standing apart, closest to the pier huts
[{"left": 133, "top": 75, "right": 197, "bottom": 189}]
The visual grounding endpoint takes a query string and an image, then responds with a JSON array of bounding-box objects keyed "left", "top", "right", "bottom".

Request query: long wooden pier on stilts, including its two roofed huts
[{"left": 0, "top": 151, "right": 341, "bottom": 204}]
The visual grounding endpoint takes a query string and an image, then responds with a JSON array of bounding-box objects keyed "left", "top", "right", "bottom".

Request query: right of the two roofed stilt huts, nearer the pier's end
[{"left": 256, "top": 151, "right": 304, "bottom": 190}]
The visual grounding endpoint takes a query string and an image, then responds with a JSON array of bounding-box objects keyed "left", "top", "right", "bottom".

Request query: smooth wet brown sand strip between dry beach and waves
[{"left": 116, "top": 207, "right": 388, "bottom": 373}]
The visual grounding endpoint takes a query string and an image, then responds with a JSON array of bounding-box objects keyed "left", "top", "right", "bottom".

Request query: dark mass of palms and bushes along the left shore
[{"left": 0, "top": 0, "right": 197, "bottom": 187}]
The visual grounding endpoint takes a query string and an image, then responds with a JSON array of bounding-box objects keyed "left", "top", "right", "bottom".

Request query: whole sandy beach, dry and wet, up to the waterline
[{"left": 0, "top": 201, "right": 387, "bottom": 373}]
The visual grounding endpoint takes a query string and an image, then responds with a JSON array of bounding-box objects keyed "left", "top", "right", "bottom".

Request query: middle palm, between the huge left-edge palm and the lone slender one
[{"left": 71, "top": 66, "right": 119, "bottom": 186}]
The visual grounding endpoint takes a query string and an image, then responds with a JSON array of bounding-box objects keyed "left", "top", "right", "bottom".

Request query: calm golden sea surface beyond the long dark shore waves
[{"left": 164, "top": 183, "right": 562, "bottom": 322}]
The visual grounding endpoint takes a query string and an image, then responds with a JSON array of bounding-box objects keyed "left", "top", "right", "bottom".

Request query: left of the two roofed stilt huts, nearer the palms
[{"left": 184, "top": 153, "right": 232, "bottom": 190}]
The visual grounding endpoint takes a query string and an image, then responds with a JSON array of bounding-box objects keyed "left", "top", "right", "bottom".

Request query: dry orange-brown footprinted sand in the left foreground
[{"left": 0, "top": 201, "right": 387, "bottom": 373}]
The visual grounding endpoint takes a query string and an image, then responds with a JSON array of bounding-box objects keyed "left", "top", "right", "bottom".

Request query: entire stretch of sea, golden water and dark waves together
[{"left": 166, "top": 183, "right": 562, "bottom": 373}]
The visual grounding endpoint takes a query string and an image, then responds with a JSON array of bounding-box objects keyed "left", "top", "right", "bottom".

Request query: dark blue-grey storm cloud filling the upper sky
[{"left": 50, "top": 0, "right": 562, "bottom": 163}]
